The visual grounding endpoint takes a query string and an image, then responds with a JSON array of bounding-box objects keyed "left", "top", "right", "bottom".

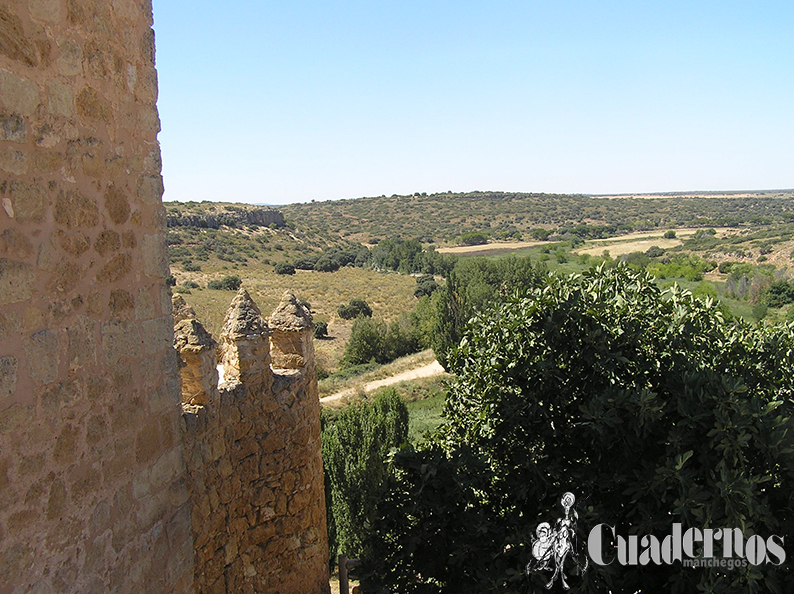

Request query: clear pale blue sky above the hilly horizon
[{"left": 154, "top": 0, "right": 794, "bottom": 204}]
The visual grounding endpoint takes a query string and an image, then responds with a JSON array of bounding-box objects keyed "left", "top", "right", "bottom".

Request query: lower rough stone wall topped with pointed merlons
[{"left": 175, "top": 289, "right": 328, "bottom": 594}]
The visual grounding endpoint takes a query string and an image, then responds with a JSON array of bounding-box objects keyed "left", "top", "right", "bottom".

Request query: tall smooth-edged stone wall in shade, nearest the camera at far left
[{"left": 0, "top": 0, "right": 194, "bottom": 594}]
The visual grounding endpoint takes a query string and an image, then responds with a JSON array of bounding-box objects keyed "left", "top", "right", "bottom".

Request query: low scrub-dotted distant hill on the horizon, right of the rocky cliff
[{"left": 279, "top": 191, "right": 794, "bottom": 243}]
